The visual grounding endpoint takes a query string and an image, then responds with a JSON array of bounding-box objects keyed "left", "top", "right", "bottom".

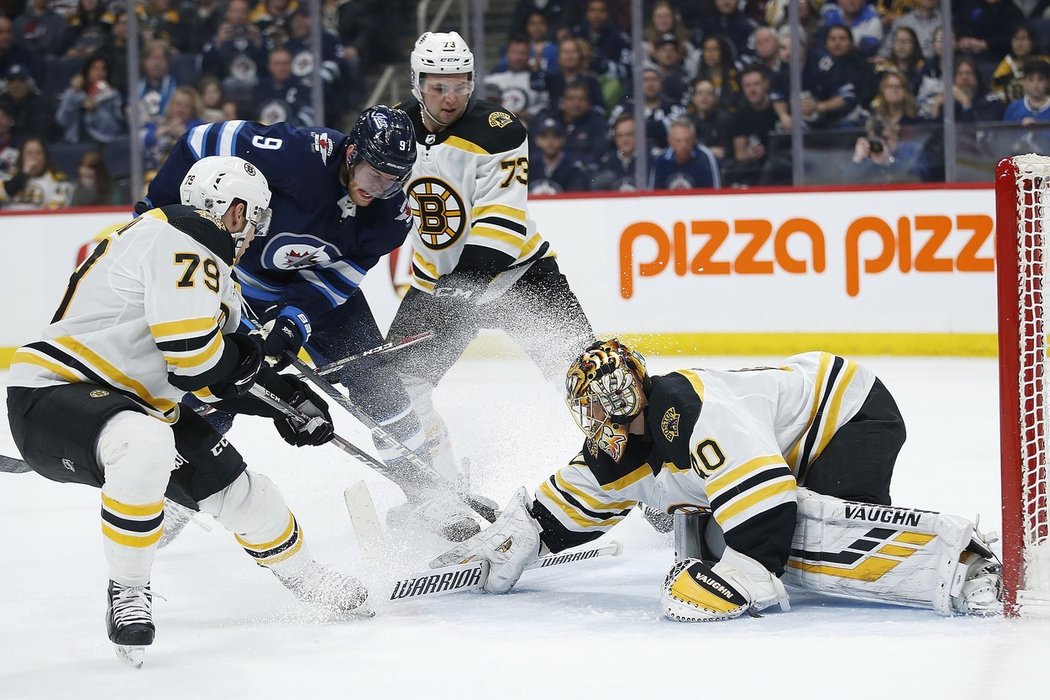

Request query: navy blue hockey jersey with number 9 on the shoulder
[{"left": 141, "top": 120, "right": 412, "bottom": 321}]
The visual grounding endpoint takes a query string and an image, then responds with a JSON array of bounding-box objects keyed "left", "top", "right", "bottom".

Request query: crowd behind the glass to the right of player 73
[{"left": 485, "top": 0, "right": 1050, "bottom": 193}]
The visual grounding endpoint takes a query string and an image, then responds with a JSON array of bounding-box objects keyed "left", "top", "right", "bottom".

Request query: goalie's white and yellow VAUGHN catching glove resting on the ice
[{"left": 660, "top": 547, "right": 791, "bottom": 622}]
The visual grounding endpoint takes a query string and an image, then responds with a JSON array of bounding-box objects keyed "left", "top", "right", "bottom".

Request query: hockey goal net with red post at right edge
[{"left": 995, "top": 154, "right": 1050, "bottom": 615}]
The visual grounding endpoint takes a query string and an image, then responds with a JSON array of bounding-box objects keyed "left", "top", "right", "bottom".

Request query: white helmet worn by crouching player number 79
[{"left": 179, "top": 155, "right": 270, "bottom": 251}]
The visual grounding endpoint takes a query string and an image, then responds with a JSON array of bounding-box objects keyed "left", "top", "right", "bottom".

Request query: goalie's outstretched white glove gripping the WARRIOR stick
[{"left": 431, "top": 487, "right": 543, "bottom": 593}]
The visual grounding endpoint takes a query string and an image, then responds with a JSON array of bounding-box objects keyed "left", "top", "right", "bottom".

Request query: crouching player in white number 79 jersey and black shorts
[{"left": 7, "top": 157, "right": 366, "bottom": 665}]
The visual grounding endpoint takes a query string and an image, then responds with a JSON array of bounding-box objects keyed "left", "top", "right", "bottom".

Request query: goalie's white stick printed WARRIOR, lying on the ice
[{"left": 387, "top": 540, "right": 624, "bottom": 601}]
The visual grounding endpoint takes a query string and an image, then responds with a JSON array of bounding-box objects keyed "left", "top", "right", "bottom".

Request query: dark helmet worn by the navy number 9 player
[{"left": 347, "top": 105, "right": 416, "bottom": 197}]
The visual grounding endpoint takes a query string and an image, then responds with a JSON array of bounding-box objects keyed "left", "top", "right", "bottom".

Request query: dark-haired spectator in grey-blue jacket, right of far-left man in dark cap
[{"left": 55, "top": 56, "right": 126, "bottom": 144}]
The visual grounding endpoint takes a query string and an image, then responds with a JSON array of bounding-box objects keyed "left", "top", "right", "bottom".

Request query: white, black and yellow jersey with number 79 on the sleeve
[{"left": 8, "top": 205, "right": 240, "bottom": 422}]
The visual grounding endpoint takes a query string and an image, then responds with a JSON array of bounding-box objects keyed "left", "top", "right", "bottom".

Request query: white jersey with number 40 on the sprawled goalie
[{"left": 536, "top": 353, "right": 876, "bottom": 570}]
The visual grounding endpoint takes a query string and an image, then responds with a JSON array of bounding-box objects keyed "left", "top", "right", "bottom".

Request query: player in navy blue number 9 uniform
[{"left": 137, "top": 105, "right": 479, "bottom": 542}]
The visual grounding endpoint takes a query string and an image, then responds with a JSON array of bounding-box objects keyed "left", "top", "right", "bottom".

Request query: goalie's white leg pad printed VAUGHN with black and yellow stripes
[{"left": 781, "top": 488, "right": 998, "bottom": 615}]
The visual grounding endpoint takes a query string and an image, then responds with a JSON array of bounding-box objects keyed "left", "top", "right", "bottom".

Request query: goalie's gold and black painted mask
[{"left": 565, "top": 338, "right": 649, "bottom": 462}]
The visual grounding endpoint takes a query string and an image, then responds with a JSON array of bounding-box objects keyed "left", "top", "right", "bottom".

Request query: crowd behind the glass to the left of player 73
[{"left": 0, "top": 0, "right": 396, "bottom": 209}]
